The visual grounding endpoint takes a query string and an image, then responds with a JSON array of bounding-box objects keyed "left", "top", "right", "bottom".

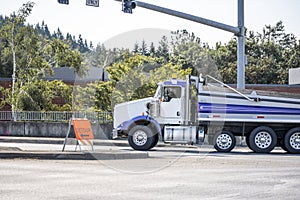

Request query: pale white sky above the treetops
[{"left": 0, "top": 0, "right": 300, "bottom": 45}]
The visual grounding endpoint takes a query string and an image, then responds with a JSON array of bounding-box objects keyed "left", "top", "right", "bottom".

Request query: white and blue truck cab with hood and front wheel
[{"left": 113, "top": 76, "right": 204, "bottom": 150}]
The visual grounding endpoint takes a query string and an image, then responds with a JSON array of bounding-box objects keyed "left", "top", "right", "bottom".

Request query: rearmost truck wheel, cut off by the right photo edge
[{"left": 284, "top": 127, "right": 300, "bottom": 153}]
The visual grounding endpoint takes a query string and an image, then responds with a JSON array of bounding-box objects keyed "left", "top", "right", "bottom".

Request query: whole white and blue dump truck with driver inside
[{"left": 113, "top": 76, "right": 300, "bottom": 153}]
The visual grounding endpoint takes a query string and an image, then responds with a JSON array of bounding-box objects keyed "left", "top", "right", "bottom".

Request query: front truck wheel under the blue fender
[{"left": 128, "top": 125, "right": 157, "bottom": 151}]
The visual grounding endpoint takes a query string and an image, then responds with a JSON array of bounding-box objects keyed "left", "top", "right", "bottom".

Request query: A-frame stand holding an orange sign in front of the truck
[{"left": 62, "top": 118, "right": 94, "bottom": 151}]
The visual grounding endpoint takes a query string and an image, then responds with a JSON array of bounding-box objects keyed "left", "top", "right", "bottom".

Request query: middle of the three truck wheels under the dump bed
[{"left": 249, "top": 126, "right": 277, "bottom": 153}]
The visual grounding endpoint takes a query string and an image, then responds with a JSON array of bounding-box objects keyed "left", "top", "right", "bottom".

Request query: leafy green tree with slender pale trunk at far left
[{"left": 0, "top": 2, "right": 84, "bottom": 112}]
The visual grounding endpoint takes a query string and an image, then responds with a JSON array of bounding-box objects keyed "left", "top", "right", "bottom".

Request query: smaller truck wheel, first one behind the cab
[{"left": 214, "top": 131, "right": 236, "bottom": 152}]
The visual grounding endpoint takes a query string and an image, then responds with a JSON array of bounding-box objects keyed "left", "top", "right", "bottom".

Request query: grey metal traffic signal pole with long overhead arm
[{"left": 115, "top": 0, "right": 245, "bottom": 89}]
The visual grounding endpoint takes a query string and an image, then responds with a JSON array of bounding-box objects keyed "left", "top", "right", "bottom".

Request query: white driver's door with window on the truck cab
[{"left": 160, "top": 86, "right": 182, "bottom": 119}]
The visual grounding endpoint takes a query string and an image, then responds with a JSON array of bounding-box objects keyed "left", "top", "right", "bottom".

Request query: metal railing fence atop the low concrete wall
[{"left": 0, "top": 111, "right": 112, "bottom": 124}]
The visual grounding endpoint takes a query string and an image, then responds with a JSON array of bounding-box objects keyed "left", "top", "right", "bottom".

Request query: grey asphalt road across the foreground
[{"left": 0, "top": 147, "right": 300, "bottom": 200}]
